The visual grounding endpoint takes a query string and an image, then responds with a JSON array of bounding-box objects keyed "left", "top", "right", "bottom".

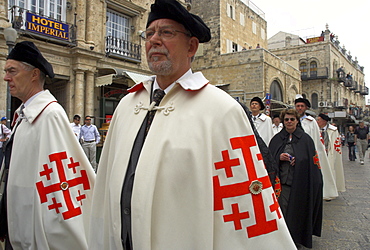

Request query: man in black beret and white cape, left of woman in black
[{"left": 250, "top": 96, "right": 274, "bottom": 145}]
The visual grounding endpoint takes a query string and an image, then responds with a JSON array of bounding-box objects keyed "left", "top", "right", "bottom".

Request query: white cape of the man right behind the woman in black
[{"left": 301, "top": 116, "right": 338, "bottom": 200}]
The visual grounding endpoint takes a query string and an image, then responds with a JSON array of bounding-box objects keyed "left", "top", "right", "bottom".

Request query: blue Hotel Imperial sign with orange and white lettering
[{"left": 26, "top": 12, "right": 69, "bottom": 41}]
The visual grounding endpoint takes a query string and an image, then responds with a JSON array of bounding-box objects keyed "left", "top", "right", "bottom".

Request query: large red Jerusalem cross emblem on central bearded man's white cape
[{"left": 213, "top": 135, "right": 281, "bottom": 238}]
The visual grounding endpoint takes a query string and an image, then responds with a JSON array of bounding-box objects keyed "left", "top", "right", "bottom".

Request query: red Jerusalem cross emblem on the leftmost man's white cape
[{"left": 36, "top": 152, "right": 90, "bottom": 220}]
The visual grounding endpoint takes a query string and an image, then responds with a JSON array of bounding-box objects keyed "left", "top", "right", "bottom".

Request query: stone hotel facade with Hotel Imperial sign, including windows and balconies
[{"left": 0, "top": 0, "right": 151, "bottom": 127}]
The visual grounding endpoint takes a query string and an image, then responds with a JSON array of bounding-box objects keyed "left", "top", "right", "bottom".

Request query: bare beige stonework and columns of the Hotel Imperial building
[{"left": 0, "top": 0, "right": 152, "bottom": 119}]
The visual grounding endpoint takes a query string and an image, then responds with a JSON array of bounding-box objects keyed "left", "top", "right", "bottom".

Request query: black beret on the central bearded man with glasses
[{"left": 146, "top": 0, "right": 211, "bottom": 43}]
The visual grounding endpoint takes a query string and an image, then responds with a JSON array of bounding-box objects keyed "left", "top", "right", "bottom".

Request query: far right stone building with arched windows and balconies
[{"left": 269, "top": 25, "right": 369, "bottom": 127}]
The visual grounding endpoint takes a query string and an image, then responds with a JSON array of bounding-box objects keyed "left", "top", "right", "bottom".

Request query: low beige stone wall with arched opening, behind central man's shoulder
[{"left": 193, "top": 49, "right": 301, "bottom": 103}]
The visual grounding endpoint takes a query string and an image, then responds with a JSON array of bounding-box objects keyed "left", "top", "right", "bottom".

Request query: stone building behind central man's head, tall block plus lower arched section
[{"left": 191, "top": 0, "right": 302, "bottom": 111}]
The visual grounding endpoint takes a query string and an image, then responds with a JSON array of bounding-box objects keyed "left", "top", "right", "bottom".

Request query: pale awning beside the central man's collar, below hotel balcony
[{"left": 95, "top": 68, "right": 150, "bottom": 87}]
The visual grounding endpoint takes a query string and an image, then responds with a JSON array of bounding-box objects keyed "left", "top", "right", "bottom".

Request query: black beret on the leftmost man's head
[{"left": 7, "top": 41, "right": 54, "bottom": 78}]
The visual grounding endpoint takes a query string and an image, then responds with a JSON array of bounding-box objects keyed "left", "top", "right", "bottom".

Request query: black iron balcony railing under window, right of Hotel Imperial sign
[{"left": 105, "top": 36, "right": 141, "bottom": 62}]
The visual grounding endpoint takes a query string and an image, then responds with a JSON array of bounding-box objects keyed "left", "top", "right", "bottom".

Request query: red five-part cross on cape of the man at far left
[{"left": 36, "top": 152, "right": 90, "bottom": 220}]
